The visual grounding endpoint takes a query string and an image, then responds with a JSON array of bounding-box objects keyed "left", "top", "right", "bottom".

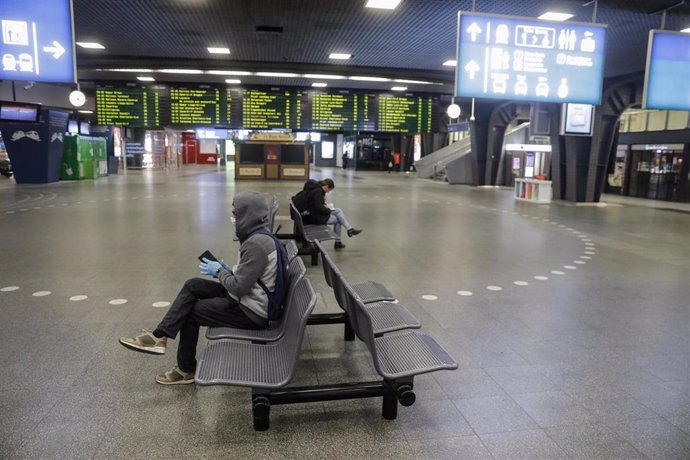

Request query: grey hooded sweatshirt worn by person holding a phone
[{"left": 218, "top": 192, "right": 278, "bottom": 326}]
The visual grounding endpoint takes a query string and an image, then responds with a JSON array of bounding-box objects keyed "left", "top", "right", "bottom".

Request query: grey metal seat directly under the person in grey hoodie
[{"left": 206, "top": 251, "right": 307, "bottom": 343}]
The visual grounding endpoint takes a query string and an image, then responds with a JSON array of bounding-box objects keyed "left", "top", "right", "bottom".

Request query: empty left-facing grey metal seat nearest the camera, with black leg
[{"left": 194, "top": 278, "right": 316, "bottom": 431}]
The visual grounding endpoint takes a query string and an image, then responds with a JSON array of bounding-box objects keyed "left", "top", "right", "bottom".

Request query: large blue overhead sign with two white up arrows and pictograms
[{"left": 455, "top": 12, "right": 606, "bottom": 104}]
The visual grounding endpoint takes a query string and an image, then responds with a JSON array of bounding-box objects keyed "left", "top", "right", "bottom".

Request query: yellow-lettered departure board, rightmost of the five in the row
[{"left": 377, "top": 95, "right": 433, "bottom": 133}]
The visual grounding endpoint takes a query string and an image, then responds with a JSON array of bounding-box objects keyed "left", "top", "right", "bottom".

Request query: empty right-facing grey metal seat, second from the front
[{"left": 316, "top": 241, "right": 422, "bottom": 340}]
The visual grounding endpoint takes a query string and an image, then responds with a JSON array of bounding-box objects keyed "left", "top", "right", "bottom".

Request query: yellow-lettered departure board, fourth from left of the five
[{"left": 310, "top": 92, "right": 374, "bottom": 131}]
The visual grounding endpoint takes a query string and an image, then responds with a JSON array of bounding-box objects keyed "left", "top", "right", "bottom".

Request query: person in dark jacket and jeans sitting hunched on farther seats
[{"left": 292, "top": 179, "right": 362, "bottom": 249}]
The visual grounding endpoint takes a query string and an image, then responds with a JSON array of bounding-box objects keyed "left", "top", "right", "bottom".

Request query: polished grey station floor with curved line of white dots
[{"left": 0, "top": 168, "right": 690, "bottom": 459}]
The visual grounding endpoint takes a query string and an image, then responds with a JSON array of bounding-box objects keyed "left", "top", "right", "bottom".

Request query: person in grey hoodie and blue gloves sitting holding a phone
[{"left": 120, "top": 192, "right": 278, "bottom": 385}]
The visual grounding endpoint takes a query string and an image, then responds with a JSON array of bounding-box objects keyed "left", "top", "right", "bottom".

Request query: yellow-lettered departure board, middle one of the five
[{"left": 238, "top": 89, "right": 302, "bottom": 129}]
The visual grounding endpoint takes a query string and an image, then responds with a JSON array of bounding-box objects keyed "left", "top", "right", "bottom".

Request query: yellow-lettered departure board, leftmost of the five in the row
[{"left": 96, "top": 86, "right": 161, "bottom": 126}]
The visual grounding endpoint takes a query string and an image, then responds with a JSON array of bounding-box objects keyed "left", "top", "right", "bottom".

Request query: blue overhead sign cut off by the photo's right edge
[{"left": 642, "top": 30, "right": 690, "bottom": 111}]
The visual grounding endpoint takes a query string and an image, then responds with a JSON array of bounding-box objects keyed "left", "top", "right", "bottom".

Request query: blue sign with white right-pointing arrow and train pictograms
[{"left": 0, "top": 0, "right": 76, "bottom": 83}]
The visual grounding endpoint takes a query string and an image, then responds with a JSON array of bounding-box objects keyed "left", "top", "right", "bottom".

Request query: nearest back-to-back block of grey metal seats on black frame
[{"left": 195, "top": 234, "right": 457, "bottom": 431}]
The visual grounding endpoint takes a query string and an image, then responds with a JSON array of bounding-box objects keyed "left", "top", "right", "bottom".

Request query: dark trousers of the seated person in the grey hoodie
[{"left": 157, "top": 278, "right": 259, "bottom": 372}]
